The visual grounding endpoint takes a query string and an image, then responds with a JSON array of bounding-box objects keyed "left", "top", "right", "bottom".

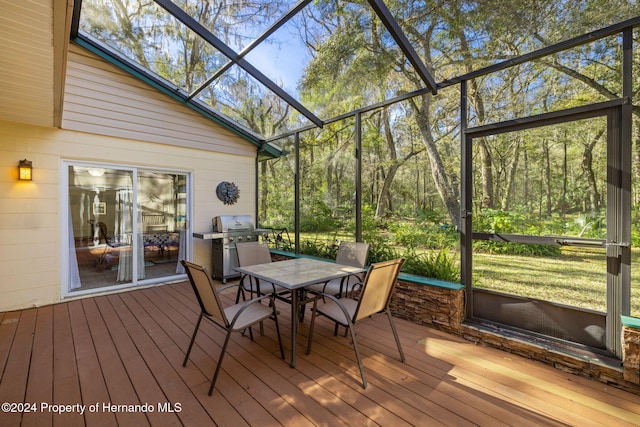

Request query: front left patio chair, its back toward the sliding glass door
[{"left": 180, "top": 260, "right": 284, "bottom": 396}]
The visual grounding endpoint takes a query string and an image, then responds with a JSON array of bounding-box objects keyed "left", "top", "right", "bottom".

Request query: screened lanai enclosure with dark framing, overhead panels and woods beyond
[{"left": 72, "top": 0, "right": 640, "bottom": 357}]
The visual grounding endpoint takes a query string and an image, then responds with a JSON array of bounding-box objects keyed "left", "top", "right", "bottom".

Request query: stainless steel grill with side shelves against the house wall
[{"left": 194, "top": 215, "right": 269, "bottom": 283}]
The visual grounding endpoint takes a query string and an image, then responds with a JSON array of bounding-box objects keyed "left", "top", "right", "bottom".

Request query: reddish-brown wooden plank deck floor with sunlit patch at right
[{"left": 0, "top": 282, "right": 640, "bottom": 427}]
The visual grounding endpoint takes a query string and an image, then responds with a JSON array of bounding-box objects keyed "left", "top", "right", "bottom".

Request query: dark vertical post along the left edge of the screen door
[{"left": 460, "top": 80, "right": 473, "bottom": 318}]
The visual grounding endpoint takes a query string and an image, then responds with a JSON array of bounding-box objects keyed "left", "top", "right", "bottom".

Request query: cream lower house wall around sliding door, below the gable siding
[{"left": 0, "top": 121, "right": 256, "bottom": 312}]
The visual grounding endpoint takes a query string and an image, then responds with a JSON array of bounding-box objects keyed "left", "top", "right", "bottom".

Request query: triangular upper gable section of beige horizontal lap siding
[{"left": 62, "top": 45, "right": 256, "bottom": 156}]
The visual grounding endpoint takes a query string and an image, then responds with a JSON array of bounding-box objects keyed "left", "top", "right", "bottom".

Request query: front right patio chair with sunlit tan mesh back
[{"left": 307, "top": 258, "right": 405, "bottom": 388}]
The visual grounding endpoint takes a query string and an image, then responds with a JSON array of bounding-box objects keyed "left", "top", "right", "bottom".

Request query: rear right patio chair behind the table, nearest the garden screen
[{"left": 307, "top": 242, "right": 370, "bottom": 298}]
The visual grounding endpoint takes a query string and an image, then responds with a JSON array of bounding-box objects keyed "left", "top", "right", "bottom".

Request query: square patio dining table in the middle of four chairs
[{"left": 235, "top": 258, "right": 365, "bottom": 368}]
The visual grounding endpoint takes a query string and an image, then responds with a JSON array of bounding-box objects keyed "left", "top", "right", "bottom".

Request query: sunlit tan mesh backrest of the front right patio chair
[{"left": 353, "top": 258, "right": 404, "bottom": 322}]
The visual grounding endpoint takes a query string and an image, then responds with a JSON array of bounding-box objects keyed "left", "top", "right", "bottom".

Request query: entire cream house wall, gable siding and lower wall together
[{"left": 0, "top": 47, "right": 256, "bottom": 312}]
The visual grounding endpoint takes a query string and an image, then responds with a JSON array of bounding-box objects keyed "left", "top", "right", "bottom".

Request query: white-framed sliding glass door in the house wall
[{"left": 63, "top": 162, "right": 189, "bottom": 294}]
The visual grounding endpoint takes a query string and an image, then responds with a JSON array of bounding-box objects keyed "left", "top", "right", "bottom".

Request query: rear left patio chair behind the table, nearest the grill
[{"left": 236, "top": 241, "right": 289, "bottom": 303}]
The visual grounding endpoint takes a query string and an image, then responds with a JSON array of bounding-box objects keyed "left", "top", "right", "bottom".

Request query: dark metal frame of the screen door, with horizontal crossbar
[{"left": 460, "top": 98, "right": 631, "bottom": 358}]
